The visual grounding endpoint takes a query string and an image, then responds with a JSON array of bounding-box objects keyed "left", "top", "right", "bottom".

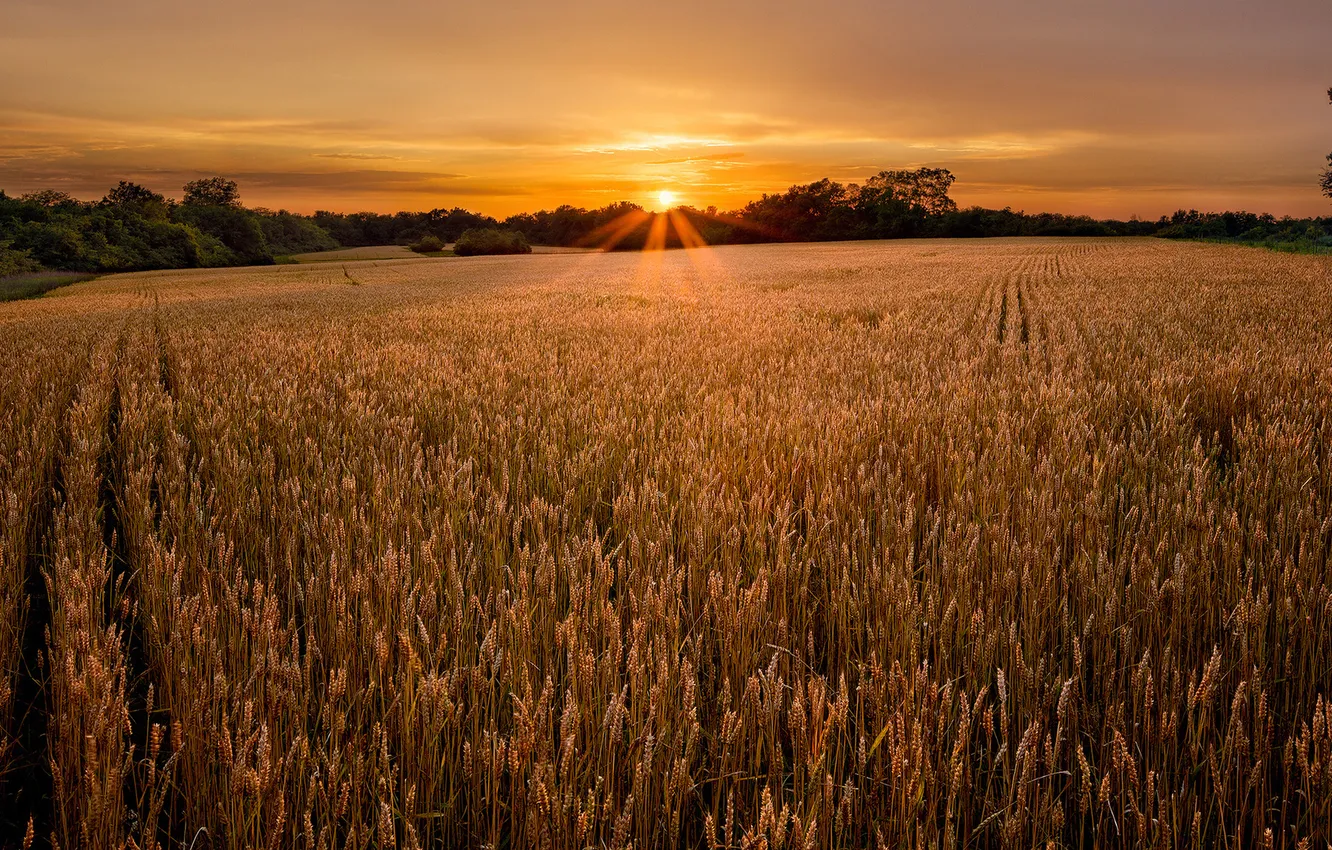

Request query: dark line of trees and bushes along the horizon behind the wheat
[{"left": 0, "top": 167, "right": 1332, "bottom": 277}]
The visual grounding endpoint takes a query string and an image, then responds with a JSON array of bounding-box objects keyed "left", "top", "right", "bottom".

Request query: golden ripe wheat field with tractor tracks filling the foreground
[{"left": 0, "top": 238, "right": 1332, "bottom": 849}]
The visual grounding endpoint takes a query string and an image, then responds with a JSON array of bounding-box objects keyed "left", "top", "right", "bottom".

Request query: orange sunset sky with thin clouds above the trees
[{"left": 0, "top": 0, "right": 1332, "bottom": 218}]
